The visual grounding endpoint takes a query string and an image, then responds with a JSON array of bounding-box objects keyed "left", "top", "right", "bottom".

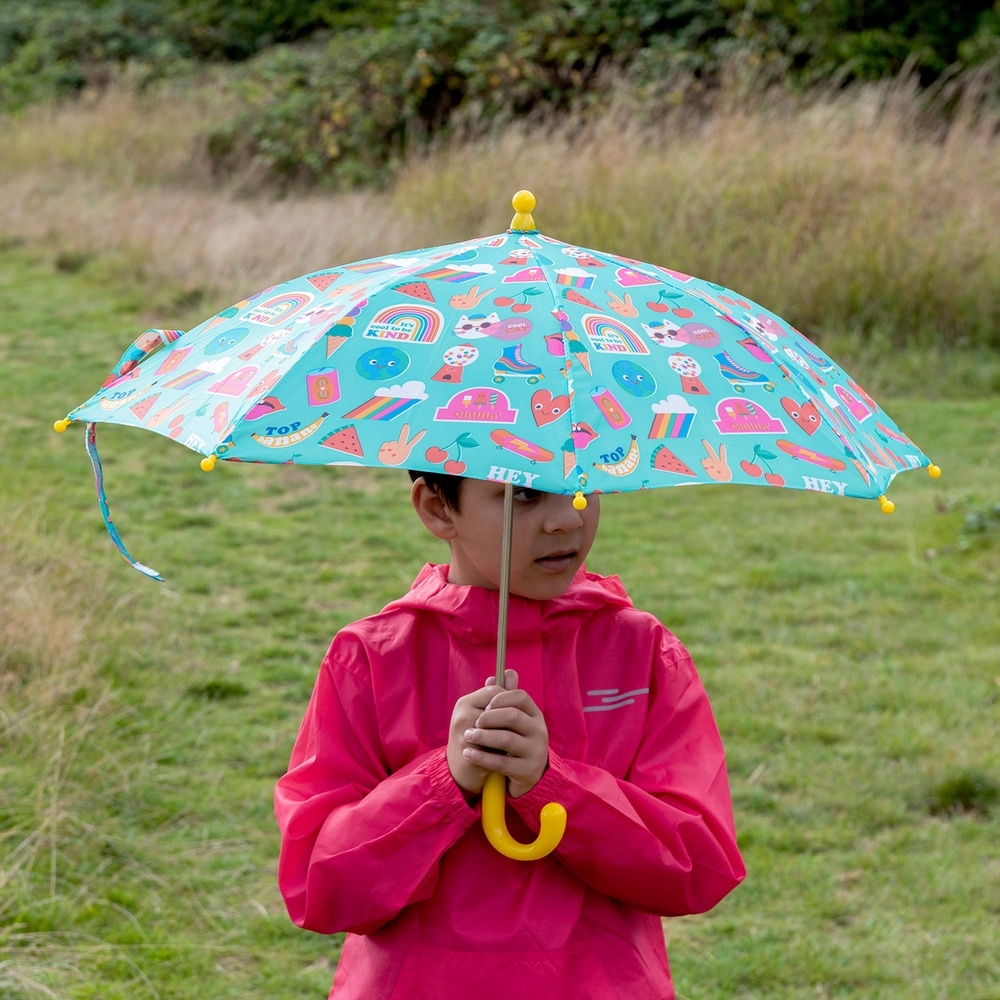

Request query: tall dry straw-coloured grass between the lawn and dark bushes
[{"left": 0, "top": 80, "right": 1000, "bottom": 345}]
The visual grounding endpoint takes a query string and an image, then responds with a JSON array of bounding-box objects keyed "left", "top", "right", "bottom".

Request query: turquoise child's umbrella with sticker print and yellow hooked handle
[{"left": 55, "top": 191, "right": 940, "bottom": 857}]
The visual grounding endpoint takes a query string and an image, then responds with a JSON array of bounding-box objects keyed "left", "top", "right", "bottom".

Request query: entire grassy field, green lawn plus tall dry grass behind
[{"left": 0, "top": 68, "right": 1000, "bottom": 1000}]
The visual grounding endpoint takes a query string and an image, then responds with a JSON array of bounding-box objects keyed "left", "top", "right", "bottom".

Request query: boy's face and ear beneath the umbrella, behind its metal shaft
[{"left": 418, "top": 479, "right": 601, "bottom": 601}]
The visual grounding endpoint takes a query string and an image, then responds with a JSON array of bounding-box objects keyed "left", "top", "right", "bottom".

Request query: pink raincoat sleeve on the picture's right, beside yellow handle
[{"left": 510, "top": 626, "right": 746, "bottom": 916}]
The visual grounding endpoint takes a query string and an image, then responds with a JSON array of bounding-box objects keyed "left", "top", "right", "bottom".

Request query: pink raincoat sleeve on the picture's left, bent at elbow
[{"left": 275, "top": 633, "right": 479, "bottom": 934}]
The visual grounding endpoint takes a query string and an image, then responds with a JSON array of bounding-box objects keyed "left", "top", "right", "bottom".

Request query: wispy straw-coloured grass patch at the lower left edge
[{"left": 0, "top": 508, "right": 172, "bottom": 1000}]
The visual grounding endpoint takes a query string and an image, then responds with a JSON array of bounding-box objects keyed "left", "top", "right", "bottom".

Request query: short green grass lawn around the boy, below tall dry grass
[{"left": 0, "top": 246, "right": 1000, "bottom": 1000}]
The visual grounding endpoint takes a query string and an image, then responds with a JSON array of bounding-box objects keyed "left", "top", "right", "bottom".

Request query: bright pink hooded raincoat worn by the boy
[{"left": 275, "top": 566, "right": 745, "bottom": 1000}]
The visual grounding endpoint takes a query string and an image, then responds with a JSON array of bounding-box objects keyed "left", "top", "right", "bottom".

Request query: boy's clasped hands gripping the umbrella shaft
[{"left": 463, "top": 670, "right": 549, "bottom": 799}]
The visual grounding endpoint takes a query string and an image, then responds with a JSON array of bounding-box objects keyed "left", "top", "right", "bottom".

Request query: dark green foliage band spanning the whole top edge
[{"left": 0, "top": 0, "right": 1000, "bottom": 186}]
